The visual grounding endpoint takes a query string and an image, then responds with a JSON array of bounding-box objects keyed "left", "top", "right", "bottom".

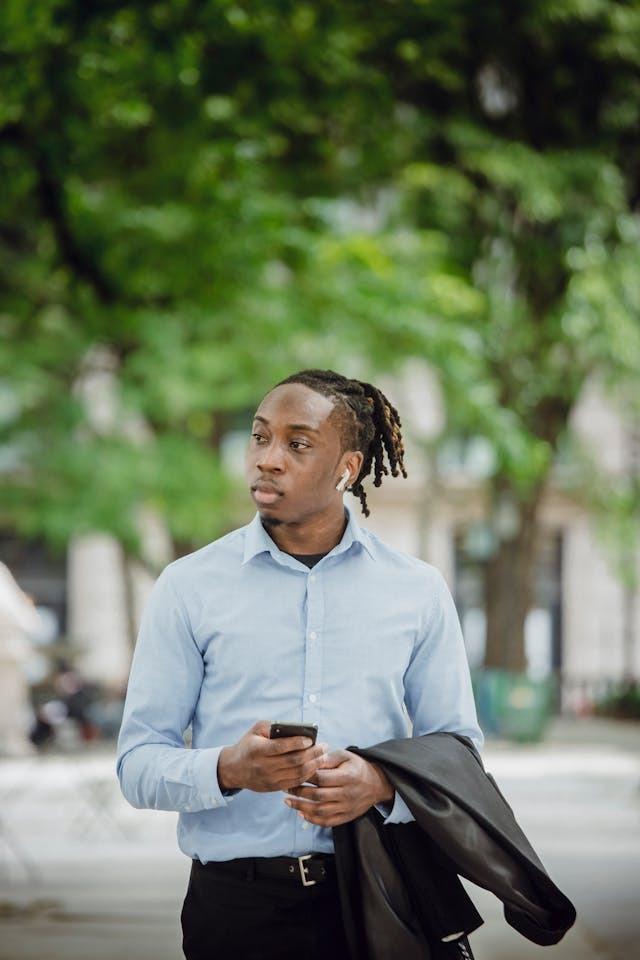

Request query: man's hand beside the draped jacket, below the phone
[{"left": 284, "top": 750, "right": 395, "bottom": 827}]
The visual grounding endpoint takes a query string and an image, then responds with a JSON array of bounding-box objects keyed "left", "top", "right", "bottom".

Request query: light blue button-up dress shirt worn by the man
[{"left": 117, "top": 504, "right": 484, "bottom": 863}]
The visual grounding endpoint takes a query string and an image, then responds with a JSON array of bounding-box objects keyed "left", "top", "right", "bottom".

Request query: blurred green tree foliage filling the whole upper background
[{"left": 0, "top": 0, "right": 640, "bottom": 564}]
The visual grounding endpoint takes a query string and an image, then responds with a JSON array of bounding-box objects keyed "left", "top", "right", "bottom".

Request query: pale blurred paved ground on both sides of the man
[{"left": 0, "top": 720, "right": 640, "bottom": 960}]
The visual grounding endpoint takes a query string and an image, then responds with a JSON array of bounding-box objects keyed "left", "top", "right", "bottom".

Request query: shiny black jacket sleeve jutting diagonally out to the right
[{"left": 378, "top": 732, "right": 576, "bottom": 946}]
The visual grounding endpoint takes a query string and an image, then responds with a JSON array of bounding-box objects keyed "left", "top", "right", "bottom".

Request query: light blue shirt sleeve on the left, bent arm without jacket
[{"left": 116, "top": 564, "right": 238, "bottom": 813}]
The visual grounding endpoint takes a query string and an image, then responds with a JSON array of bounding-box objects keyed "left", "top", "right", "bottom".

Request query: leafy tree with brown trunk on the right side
[{"left": 342, "top": 2, "right": 640, "bottom": 670}]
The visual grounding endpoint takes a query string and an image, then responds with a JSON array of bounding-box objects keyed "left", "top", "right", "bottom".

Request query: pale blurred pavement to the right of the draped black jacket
[{"left": 476, "top": 717, "right": 640, "bottom": 960}]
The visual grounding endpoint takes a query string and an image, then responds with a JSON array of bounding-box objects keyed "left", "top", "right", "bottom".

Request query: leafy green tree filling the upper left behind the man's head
[{"left": 0, "top": 0, "right": 480, "bottom": 559}]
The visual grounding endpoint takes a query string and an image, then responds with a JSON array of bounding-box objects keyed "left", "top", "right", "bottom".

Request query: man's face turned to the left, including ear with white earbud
[{"left": 246, "top": 383, "right": 363, "bottom": 524}]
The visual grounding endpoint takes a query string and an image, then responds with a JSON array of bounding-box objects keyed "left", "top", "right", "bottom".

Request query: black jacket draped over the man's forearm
[{"left": 333, "top": 733, "right": 576, "bottom": 960}]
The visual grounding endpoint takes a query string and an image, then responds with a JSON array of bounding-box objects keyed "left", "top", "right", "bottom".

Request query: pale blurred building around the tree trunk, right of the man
[{"left": 369, "top": 367, "right": 640, "bottom": 712}]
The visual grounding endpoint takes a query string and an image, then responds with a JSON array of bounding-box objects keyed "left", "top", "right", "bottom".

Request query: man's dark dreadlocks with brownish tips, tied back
[{"left": 276, "top": 370, "right": 407, "bottom": 517}]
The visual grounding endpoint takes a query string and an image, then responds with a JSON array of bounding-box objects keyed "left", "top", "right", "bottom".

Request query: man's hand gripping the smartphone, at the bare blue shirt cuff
[{"left": 218, "top": 720, "right": 328, "bottom": 793}]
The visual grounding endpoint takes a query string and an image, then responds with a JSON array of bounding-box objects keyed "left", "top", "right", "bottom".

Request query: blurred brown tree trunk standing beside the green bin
[{"left": 484, "top": 484, "right": 543, "bottom": 672}]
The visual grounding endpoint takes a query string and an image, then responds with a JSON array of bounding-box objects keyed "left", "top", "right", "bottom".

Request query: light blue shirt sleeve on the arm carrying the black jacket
[{"left": 376, "top": 567, "right": 484, "bottom": 823}]
